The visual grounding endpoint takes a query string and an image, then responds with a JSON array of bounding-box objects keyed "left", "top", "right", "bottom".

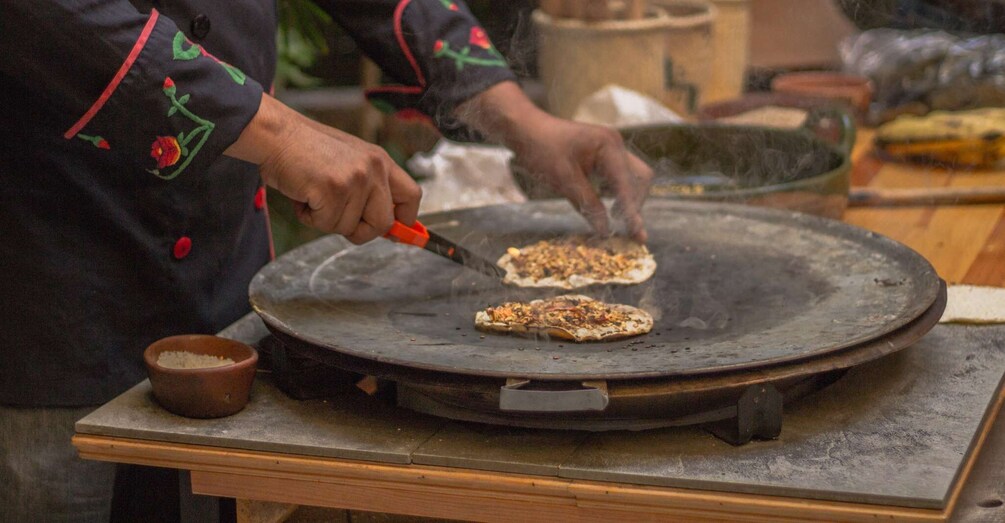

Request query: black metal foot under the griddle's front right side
[{"left": 705, "top": 383, "right": 784, "bottom": 446}]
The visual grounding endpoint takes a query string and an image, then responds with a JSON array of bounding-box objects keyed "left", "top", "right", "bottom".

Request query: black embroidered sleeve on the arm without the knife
[{"left": 322, "top": 0, "right": 516, "bottom": 140}]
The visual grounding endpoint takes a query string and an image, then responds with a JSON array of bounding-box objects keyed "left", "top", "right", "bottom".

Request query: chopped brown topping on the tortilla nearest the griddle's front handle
[{"left": 486, "top": 296, "right": 631, "bottom": 329}]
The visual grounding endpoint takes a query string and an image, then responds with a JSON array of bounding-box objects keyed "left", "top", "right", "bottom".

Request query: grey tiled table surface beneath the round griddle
[{"left": 76, "top": 316, "right": 1005, "bottom": 509}]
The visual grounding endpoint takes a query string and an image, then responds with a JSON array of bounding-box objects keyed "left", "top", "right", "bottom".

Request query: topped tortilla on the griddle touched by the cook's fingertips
[{"left": 496, "top": 236, "right": 656, "bottom": 289}]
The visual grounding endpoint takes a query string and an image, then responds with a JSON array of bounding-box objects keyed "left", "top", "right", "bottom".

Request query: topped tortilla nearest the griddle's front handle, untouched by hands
[{"left": 474, "top": 295, "right": 653, "bottom": 343}]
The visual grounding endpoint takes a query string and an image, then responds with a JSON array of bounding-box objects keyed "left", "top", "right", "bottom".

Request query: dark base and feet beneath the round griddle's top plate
[{"left": 256, "top": 282, "right": 946, "bottom": 446}]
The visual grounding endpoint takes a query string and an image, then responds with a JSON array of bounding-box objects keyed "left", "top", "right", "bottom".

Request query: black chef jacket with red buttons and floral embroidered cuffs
[{"left": 0, "top": 0, "right": 513, "bottom": 406}]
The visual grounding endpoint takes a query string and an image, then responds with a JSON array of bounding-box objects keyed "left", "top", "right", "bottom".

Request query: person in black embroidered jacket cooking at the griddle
[{"left": 0, "top": 0, "right": 651, "bottom": 521}]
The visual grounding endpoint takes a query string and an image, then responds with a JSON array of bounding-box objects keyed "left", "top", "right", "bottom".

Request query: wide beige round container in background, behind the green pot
[{"left": 532, "top": 8, "right": 670, "bottom": 118}]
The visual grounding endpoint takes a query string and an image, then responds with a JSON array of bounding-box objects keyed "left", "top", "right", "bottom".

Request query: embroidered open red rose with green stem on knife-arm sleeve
[{"left": 148, "top": 76, "right": 216, "bottom": 180}]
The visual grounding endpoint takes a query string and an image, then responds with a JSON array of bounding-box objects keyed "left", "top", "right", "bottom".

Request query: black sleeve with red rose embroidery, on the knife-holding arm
[{"left": 0, "top": 0, "right": 262, "bottom": 179}]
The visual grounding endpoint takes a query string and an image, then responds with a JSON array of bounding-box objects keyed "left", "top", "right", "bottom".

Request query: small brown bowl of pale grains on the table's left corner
[{"left": 143, "top": 334, "right": 258, "bottom": 418}]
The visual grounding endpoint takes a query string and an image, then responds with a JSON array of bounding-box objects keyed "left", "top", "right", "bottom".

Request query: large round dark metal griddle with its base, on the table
[{"left": 249, "top": 200, "right": 946, "bottom": 445}]
